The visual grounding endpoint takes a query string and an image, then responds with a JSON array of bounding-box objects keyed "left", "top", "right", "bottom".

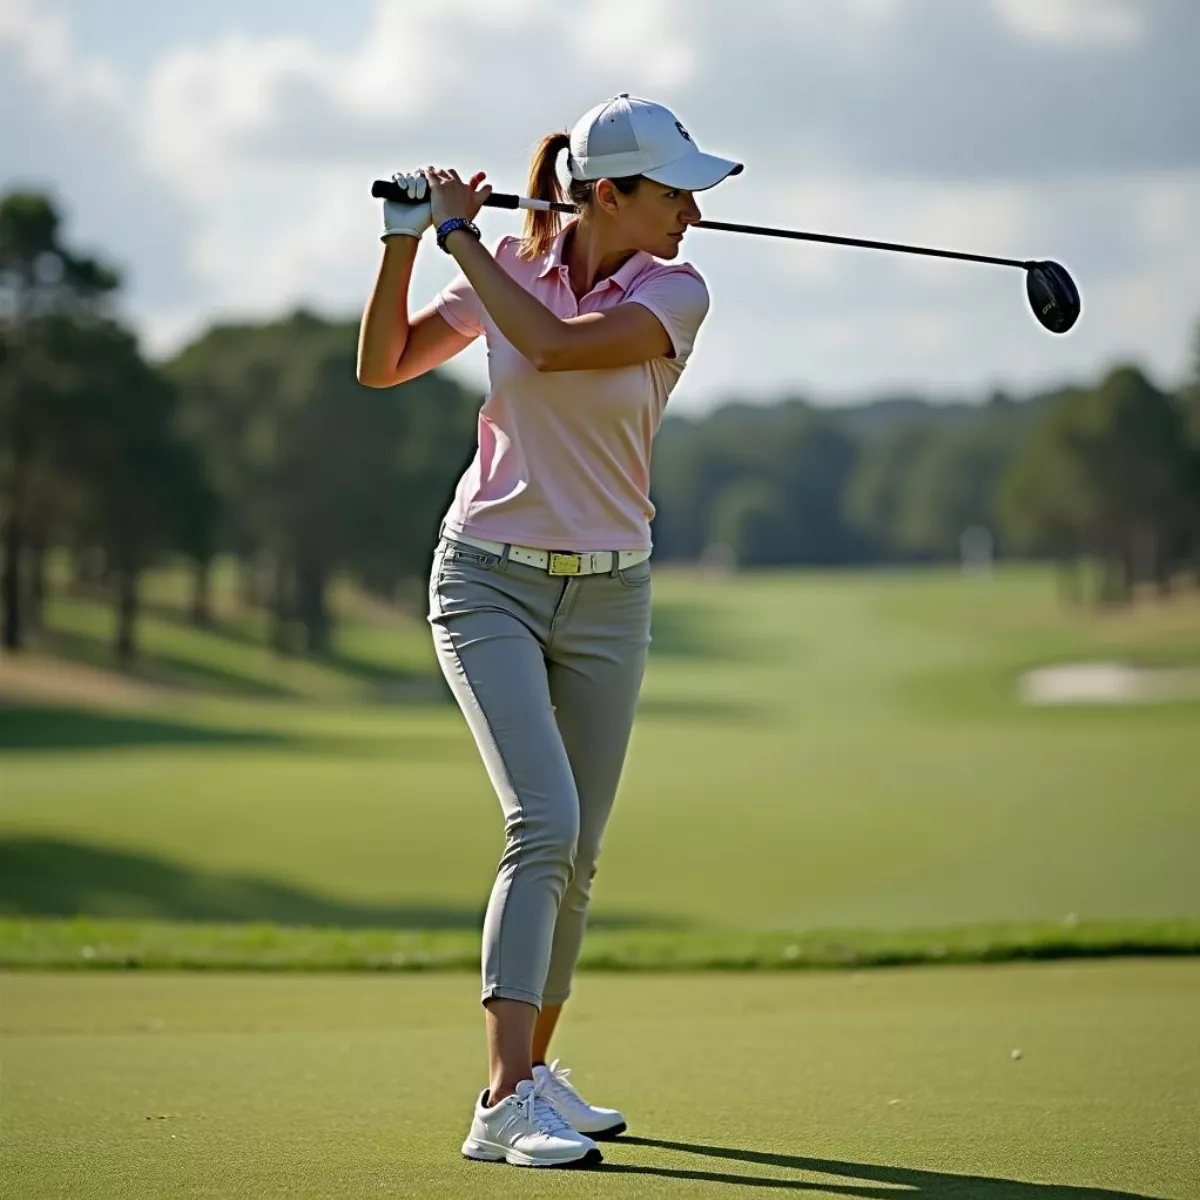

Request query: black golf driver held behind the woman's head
[{"left": 371, "top": 179, "right": 1080, "bottom": 334}]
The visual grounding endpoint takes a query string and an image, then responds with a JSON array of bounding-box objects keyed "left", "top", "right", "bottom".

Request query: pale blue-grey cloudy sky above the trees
[{"left": 0, "top": 0, "right": 1200, "bottom": 413}]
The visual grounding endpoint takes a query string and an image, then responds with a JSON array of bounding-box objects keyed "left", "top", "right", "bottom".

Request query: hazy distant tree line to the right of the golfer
[{"left": 654, "top": 355, "right": 1200, "bottom": 602}]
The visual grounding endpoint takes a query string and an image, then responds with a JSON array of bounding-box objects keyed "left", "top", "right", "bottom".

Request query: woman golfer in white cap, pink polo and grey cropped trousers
[{"left": 359, "top": 94, "right": 742, "bottom": 1166}]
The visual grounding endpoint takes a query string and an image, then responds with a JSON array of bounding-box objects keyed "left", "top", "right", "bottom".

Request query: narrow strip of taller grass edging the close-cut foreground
[{"left": 0, "top": 917, "right": 1200, "bottom": 972}]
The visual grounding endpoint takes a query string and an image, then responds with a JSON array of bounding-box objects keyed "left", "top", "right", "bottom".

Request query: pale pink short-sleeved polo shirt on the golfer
[{"left": 434, "top": 226, "right": 709, "bottom": 551}]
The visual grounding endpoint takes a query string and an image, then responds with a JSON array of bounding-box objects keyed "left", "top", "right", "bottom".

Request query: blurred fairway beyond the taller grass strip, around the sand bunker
[{"left": 0, "top": 561, "right": 1200, "bottom": 934}]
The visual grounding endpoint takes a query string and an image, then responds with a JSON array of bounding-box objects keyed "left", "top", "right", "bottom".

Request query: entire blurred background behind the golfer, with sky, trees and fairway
[{"left": 0, "top": 0, "right": 1200, "bottom": 965}]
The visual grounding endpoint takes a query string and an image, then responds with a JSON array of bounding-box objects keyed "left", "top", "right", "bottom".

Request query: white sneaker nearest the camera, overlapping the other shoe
[{"left": 462, "top": 1079, "right": 604, "bottom": 1166}]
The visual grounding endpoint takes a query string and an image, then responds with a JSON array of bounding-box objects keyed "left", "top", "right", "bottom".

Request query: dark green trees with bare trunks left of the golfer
[{"left": 0, "top": 193, "right": 479, "bottom": 659}]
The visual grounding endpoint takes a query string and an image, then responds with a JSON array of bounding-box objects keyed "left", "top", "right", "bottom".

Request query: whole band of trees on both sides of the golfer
[{"left": 0, "top": 192, "right": 1200, "bottom": 659}]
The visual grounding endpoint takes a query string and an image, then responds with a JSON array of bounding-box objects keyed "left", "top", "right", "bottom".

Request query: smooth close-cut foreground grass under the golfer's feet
[{"left": 0, "top": 960, "right": 1200, "bottom": 1200}]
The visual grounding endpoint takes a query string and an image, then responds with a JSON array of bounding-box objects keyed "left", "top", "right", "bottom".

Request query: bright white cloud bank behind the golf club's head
[{"left": 690, "top": 170, "right": 1200, "bottom": 398}]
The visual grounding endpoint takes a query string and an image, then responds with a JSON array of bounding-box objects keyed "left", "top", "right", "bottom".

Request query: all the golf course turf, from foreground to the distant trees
[{"left": 0, "top": 568, "right": 1200, "bottom": 1200}]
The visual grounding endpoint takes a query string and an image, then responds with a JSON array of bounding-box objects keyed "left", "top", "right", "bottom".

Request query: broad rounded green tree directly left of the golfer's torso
[{"left": 166, "top": 310, "right": 479, "bottom": 653}]
